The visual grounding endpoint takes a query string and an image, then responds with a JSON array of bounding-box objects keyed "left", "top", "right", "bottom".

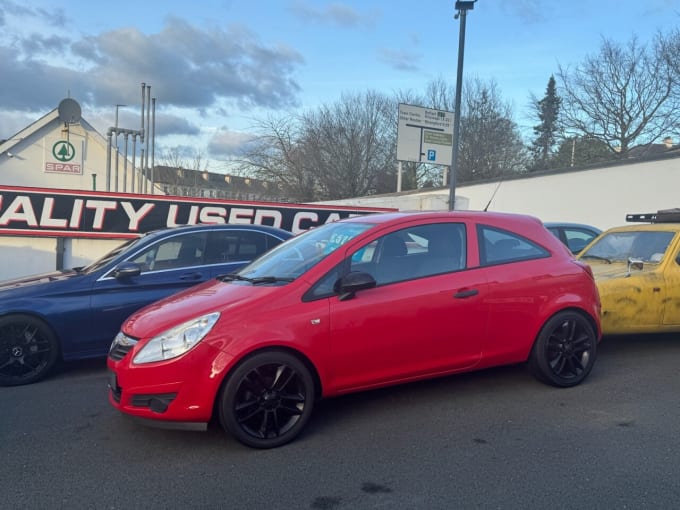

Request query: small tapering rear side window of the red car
[{"left": 477, "top": 225, "right": 550, "bottom": 266}]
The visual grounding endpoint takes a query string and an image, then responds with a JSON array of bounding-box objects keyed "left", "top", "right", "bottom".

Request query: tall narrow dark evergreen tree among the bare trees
[{"left": 531, "top": 76, "right": 562, "bottom": 170}]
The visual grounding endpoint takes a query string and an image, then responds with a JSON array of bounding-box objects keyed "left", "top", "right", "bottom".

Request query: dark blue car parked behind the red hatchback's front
[{"left": 0, "top": 224, "right": 293, "bottom": 386}]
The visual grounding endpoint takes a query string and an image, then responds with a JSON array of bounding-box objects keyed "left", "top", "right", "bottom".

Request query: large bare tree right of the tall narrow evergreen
[{"left": 558, "top": 36, "right": 678, "bottom": 157}]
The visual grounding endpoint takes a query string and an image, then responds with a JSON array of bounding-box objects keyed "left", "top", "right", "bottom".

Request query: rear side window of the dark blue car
[{"left": 205, "top": 230, "right": 281, "bottom": 264}]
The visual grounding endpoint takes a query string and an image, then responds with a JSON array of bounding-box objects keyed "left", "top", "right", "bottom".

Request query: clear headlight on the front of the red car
[{"left": 132, "top": 312, "right": 220, "bottom": 365}]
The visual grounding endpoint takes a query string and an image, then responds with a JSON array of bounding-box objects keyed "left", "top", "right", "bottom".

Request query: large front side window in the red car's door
[{"left": 350, "top": 223, "right": 467, "bottom": 285}]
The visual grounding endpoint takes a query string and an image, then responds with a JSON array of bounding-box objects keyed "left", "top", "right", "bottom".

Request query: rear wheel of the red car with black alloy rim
[{"left": 529, "top": 311, "right": 597, "bottom": 387}]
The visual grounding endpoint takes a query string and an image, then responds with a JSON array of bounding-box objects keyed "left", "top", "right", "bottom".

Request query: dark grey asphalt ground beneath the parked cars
[{"left": 0, "top": 335, "right": 680, "bottom": 510}]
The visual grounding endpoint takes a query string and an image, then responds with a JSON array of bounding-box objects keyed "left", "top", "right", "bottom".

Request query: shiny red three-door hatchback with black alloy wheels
[{"left": 108, "top": 211, "right": 600, "bottom": 448}]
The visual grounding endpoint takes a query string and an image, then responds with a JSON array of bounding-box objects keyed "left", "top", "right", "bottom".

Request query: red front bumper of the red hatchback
[{"left": 107, "top": 344, "right": 229, "bottom": 429}]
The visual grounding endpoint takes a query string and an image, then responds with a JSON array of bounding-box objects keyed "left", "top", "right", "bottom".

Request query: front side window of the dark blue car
[{"left": 131, "top": 232, "right": 206, "bottom": 273}]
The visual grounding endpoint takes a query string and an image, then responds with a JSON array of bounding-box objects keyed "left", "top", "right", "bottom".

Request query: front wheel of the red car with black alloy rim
[{"left": 218, "top": 351, "right": 315, "bottom": 448}]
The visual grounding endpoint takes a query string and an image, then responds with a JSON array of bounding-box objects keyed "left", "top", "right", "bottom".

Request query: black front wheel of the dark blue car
[{"left": 0, "top": 314, "right": 59, "bottom": 386}]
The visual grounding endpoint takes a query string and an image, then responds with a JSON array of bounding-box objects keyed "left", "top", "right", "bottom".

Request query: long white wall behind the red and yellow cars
[{"left": 316, "top": 157, "right": 680, "bottom": 229}]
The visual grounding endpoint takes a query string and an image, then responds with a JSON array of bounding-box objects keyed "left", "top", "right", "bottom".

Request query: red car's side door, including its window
[{"left": 330, "top": 223, "right": 488, "bottom": 391}]
